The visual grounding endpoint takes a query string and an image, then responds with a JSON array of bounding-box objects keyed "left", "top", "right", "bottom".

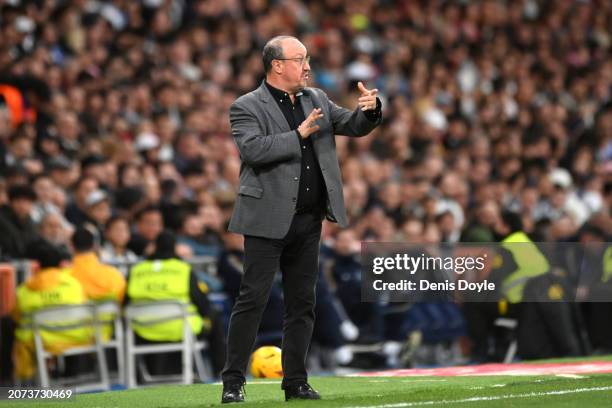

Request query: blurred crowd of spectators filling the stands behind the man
[{"left": 0, "top": 0, "right": 612, "bottom": 382}]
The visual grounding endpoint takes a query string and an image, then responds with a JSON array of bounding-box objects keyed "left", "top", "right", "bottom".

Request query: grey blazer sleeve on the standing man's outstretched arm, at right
[{"left": 317, "top": 90, "right": 382, "bottom": 137}]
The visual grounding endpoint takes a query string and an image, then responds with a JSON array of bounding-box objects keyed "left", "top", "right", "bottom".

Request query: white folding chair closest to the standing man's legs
[{"left": 125, "top": 301, "right": 212, "bottom": 388}]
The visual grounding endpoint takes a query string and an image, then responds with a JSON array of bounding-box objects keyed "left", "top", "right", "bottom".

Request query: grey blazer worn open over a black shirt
[{"left": 229, "top": 82, "right": 382, "bottom": 239}]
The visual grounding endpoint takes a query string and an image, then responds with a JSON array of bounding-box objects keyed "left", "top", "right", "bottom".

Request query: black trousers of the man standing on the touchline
[{"left": 221, "top": 213, "right": 322, "bottom": 388}]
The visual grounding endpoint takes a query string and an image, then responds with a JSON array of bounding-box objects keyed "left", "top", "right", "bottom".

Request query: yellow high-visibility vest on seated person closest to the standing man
[{"left": 127, "top": 259, "right": 203, "bottom": 341}]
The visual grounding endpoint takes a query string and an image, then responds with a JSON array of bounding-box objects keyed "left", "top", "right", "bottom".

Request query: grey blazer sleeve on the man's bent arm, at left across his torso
[{"left": 230, "top": 101, "right": 301, "bottom": 167}]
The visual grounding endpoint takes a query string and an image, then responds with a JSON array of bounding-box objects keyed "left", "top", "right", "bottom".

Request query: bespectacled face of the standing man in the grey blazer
[{"left": 278, "top": 38, "right": 310, "bottom": 92}]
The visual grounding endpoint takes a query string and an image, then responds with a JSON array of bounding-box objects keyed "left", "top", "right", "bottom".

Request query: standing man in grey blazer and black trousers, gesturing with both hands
[{"left": 222, "top": 36, "right": 382, "bottom": 402}]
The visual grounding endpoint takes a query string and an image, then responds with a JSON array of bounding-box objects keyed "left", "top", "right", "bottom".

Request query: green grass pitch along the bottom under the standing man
[{"left": 0, "top": 374, "right": 612, "bottom": 408}]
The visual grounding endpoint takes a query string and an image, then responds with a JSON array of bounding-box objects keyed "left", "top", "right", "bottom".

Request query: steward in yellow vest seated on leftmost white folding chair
[{"left": 13, "top": 241, "right": 94, "bottom": 379}]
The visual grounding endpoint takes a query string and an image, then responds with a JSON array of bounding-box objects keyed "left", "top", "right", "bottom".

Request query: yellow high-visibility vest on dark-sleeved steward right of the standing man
[{"left": 501, "top": 232, "right": 550, "bottom": 303}]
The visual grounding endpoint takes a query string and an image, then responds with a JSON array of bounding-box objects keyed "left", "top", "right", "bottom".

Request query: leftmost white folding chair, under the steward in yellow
[{"left": 32, "top": 304, "right": 110, "bottom": 392}]
